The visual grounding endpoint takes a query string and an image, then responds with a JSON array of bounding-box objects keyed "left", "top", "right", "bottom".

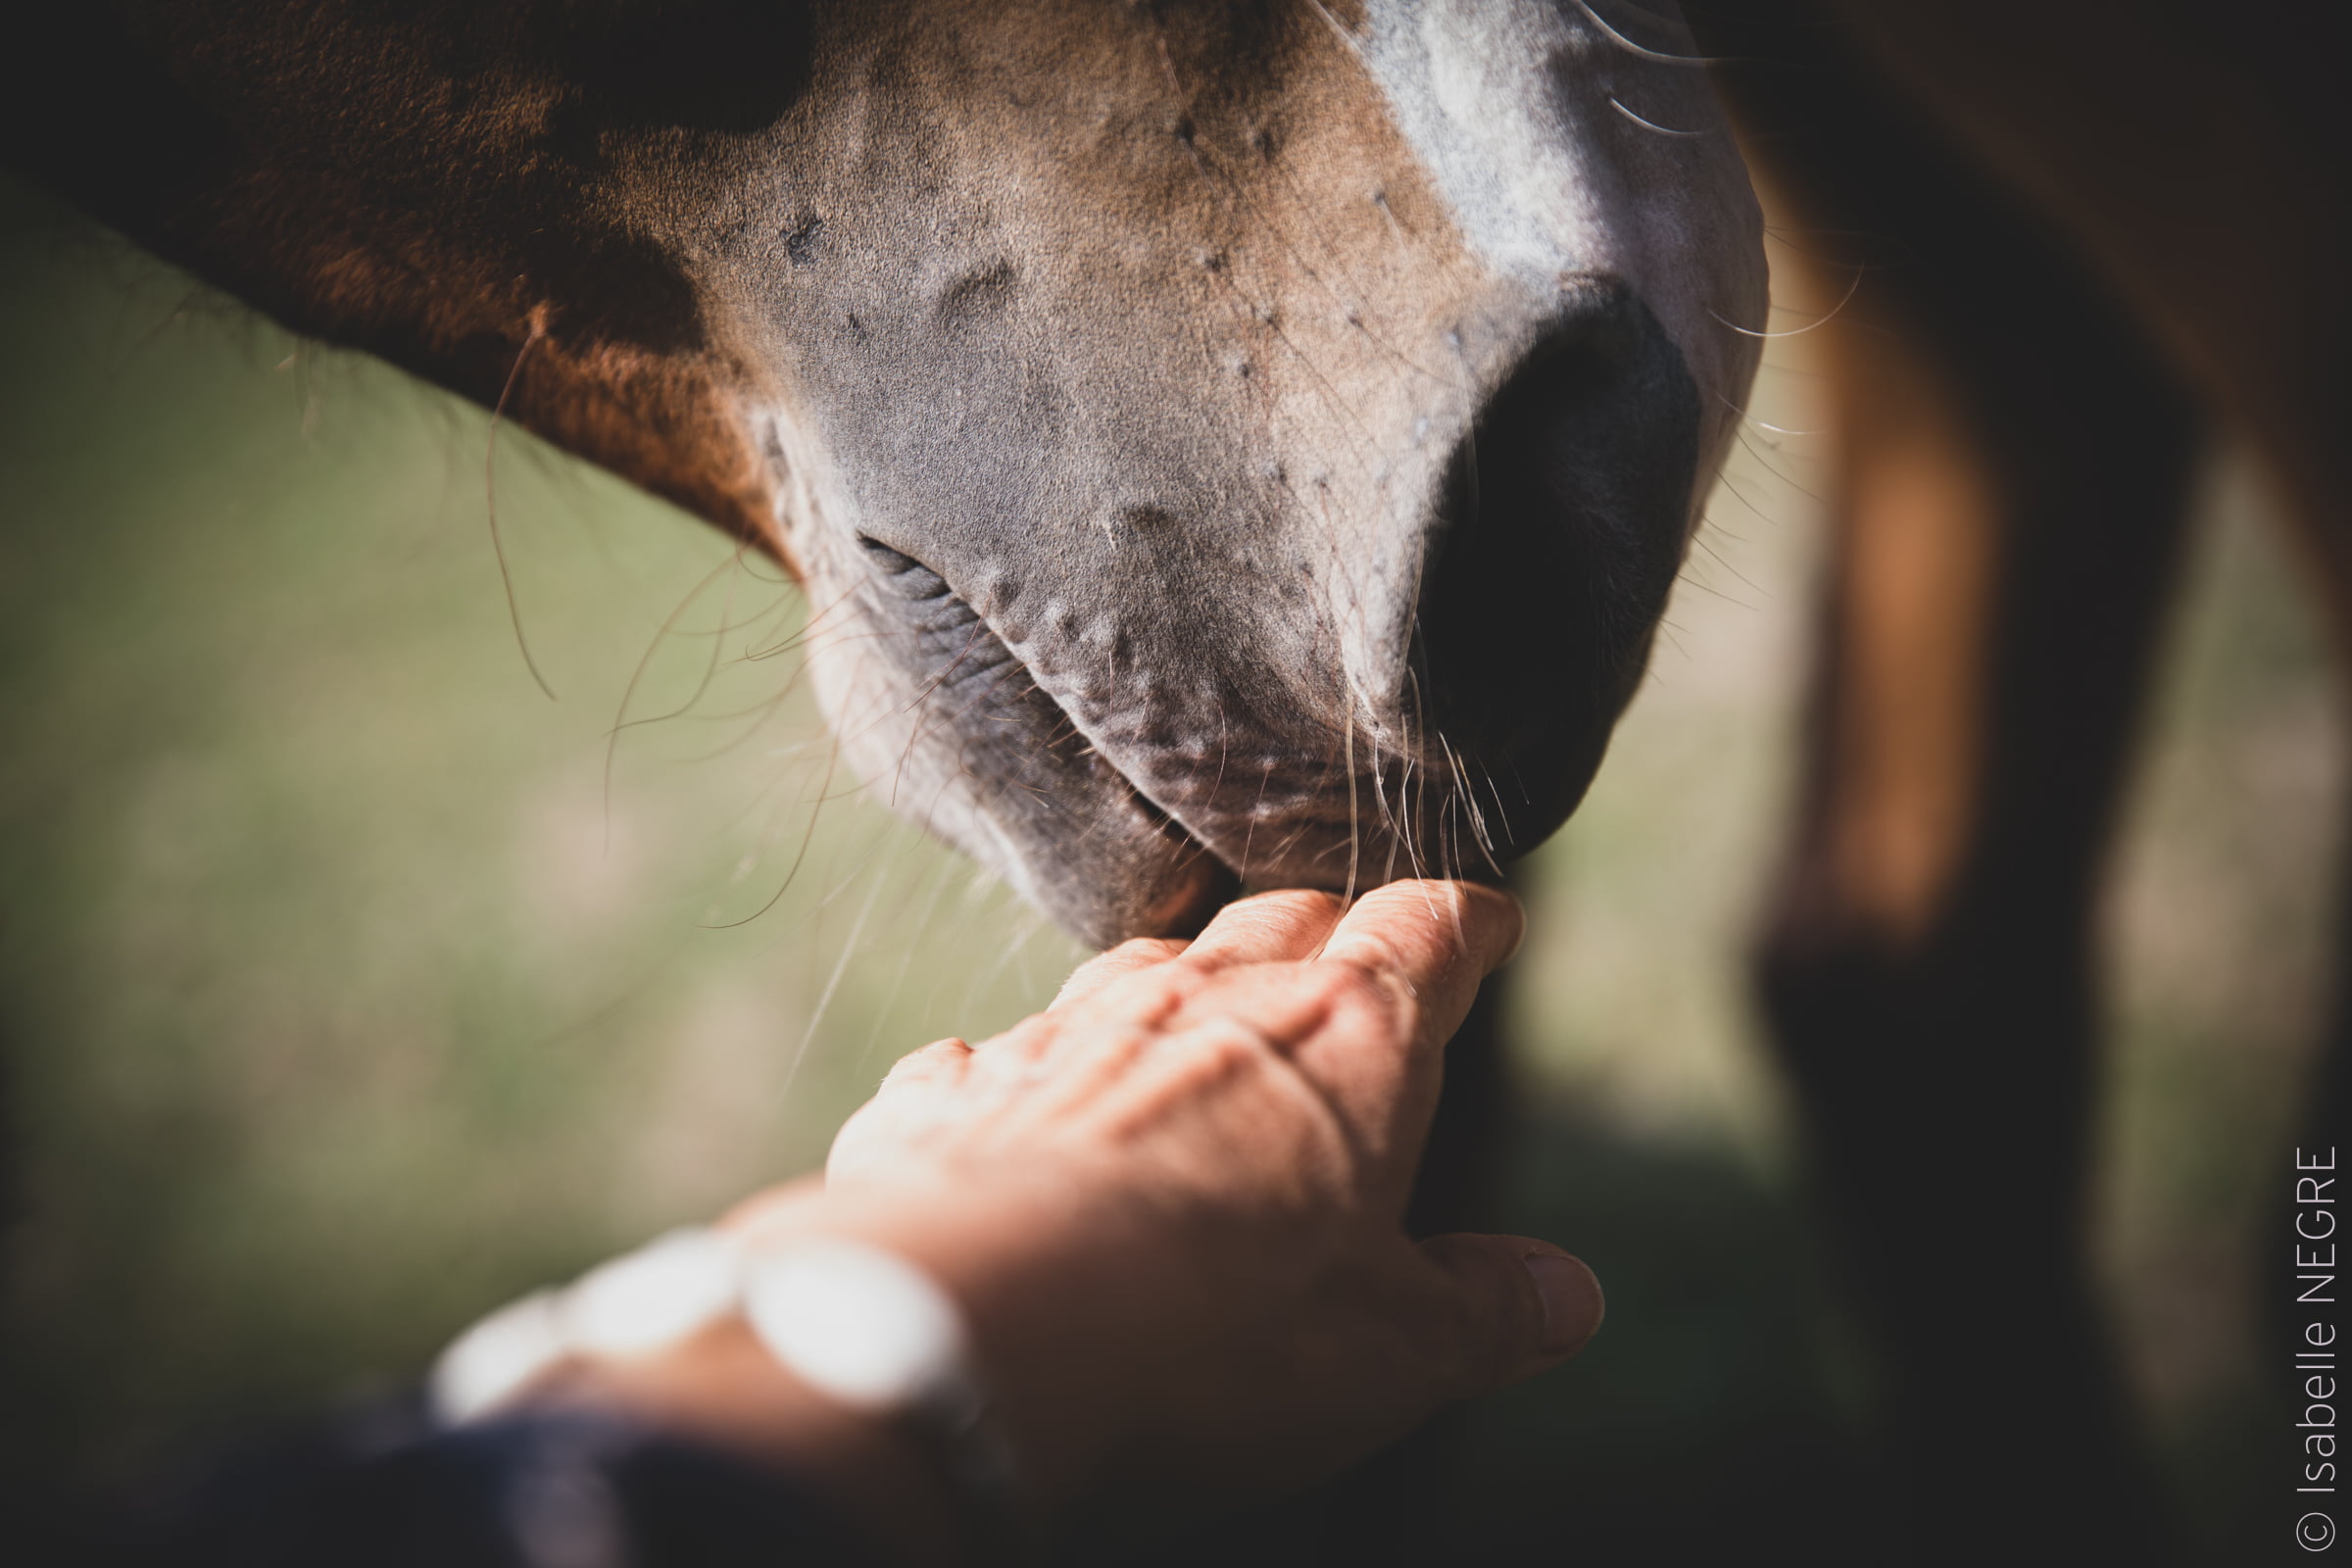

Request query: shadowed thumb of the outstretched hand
[{"left": 1421, "top": 1234, "right": 1606, "bottom": 1398}]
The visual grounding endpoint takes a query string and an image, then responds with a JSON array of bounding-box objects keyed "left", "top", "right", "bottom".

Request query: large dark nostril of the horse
[{"left": 1404, "top": 279, "right": 1700, "bottom": 856}]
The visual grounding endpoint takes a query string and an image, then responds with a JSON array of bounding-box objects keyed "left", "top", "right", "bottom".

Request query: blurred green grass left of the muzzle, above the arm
[{"left": 0, "top": 180, "right": 1096, "bottom": 1464}]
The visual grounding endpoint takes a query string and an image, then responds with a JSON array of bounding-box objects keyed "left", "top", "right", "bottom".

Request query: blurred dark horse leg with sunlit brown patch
[{"left": 1705, "top": 7, "right": 2194, "bottom": 1561}]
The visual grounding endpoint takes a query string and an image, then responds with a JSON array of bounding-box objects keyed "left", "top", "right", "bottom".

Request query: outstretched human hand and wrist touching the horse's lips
[{"left": 531, "top": 882, "right": 1601, "bottom": 1544}]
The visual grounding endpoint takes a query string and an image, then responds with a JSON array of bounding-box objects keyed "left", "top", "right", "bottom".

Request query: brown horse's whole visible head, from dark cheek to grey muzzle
[{"left": 35, "top": 0, "right": 1764, "bottom": 943}]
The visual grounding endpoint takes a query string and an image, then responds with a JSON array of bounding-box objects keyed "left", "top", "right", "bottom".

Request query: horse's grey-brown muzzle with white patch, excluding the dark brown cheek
[{"left": 699, "top": 0, "right": 1764, "bottom": 943}]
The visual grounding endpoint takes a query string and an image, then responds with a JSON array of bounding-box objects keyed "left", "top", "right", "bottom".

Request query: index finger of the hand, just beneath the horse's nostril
[{"left": 1322, "top": 882, "right": 1527, "bottom": 1039}]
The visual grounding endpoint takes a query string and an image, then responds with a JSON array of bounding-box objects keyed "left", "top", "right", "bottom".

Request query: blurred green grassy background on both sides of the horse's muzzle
[{"left": 0, "top": 172, "right": 2314, "bottom": 1563}]
